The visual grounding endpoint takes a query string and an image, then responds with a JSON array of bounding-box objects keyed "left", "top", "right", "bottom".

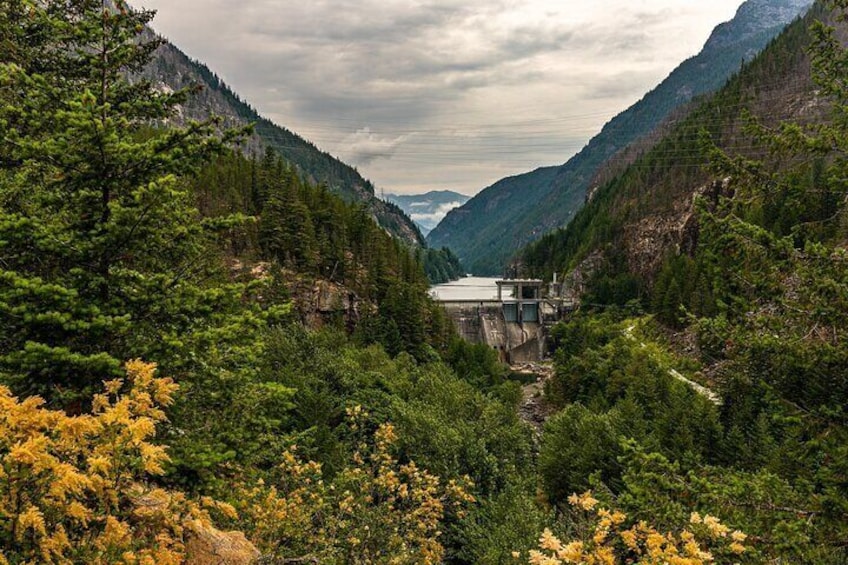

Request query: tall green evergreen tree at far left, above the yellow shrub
[{"left": 0, "top": 0, "right": 242, "bottom": 401}]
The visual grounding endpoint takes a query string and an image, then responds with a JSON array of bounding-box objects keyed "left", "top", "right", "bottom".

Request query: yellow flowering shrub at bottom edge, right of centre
[{"left": 513, "top": 492, "right": 747, "bottom": 565}]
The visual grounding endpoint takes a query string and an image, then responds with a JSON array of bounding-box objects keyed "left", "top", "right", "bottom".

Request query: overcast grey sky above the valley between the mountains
[{"left": 138, "top": 0, "right": 742, "bottom": 194}]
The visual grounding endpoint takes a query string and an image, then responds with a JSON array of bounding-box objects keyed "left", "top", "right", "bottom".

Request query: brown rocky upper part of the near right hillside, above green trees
[{"left": 522, "top": 2, "right": 824, "bottom": 281}]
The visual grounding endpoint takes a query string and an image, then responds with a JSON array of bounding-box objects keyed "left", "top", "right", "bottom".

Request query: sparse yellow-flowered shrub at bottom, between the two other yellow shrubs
[{"left": 239, "top": 409, "right": 474, "bottom": 565}]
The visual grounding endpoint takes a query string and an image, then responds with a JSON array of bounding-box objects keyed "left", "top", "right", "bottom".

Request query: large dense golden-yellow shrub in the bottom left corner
[{"left": 0, "top": 361, "right": 234, "bottom": 565}]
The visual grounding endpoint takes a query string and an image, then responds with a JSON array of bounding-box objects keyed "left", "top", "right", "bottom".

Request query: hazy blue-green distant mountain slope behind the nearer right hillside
[{"left": 429, "top": 0, "right": 812, "bottom": 273}]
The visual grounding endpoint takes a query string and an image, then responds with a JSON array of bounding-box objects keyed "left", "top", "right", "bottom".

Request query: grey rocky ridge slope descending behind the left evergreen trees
[{"left": 144, "top": 37, "right": 423, "bottom": 245}]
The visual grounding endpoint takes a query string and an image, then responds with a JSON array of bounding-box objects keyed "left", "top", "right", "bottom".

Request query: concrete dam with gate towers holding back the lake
[{"left": 434, "top": 279, "right": 570, "bottom": 365}]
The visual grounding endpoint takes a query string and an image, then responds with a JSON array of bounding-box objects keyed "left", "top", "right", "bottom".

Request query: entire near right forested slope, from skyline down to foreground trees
[{"left": 524, "top": 0, "right": 848, "bottom": 565}]
